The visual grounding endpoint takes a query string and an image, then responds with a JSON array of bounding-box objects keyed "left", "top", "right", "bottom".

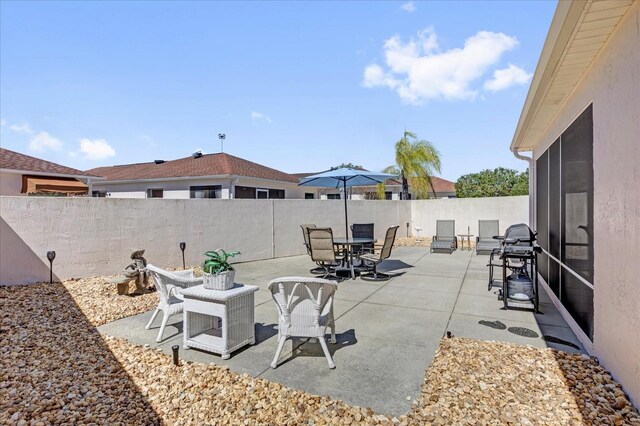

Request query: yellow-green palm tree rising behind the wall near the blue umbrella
[{"left": 383, "top": 130, "right": 440, "bottom": 200}]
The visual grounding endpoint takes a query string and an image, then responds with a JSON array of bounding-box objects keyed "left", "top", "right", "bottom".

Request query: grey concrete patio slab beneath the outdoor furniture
[{"left": 98, "top": 247, "right": 583, "bottom": 415}]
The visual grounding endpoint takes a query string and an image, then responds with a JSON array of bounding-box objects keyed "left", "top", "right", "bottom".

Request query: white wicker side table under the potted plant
[{"left": 180, "top": 283, "right": 258, "bottom": 359}]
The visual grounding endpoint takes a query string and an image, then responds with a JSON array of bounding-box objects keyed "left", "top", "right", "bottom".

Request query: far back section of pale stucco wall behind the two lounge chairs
[{"left": 411, "top": 195, "right": 529, "bottom": 237}]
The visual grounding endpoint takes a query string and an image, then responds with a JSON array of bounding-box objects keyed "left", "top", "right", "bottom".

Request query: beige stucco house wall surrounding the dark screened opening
[{"left": 534, "top": 2, "right": 640, "bottom": 404}]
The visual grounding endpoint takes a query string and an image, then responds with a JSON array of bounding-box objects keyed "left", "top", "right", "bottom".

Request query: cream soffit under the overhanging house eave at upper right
[{"left": 511, "top": 0, "right": 634, "bottom": 152}]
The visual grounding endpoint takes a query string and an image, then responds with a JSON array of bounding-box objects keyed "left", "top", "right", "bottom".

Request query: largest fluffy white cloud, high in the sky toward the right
[{"left": 363, "top": 27, "right": 518, "bottom": 104}]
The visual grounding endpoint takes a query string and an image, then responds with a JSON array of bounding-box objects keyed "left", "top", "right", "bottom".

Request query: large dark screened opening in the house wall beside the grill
[{"left": 536, "top": 105, "right": 593, "bottom": 340}]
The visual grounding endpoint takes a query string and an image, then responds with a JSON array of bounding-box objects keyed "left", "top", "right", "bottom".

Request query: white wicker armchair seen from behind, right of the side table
[{"left": 269, "top": 277, "right": 338, "bottom": 368}]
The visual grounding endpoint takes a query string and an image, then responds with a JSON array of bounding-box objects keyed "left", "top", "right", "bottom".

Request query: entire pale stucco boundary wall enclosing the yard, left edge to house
[{"left": 0, "top": 197, "right": 527, "bottom": 284}]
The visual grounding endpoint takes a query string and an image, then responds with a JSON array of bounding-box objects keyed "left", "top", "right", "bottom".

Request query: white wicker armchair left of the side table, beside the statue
[{"left": 145, "top": 265, "right": 202, "bottom": 342}]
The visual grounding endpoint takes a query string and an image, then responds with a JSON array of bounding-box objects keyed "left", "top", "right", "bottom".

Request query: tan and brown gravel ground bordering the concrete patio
[{"left": 0, "top": 278, "right": 640, "bottom": 426}]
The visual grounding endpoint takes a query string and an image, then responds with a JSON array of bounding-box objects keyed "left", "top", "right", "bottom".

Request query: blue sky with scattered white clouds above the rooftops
[{"left": 0, "top": 0, "right": 556, "bottom": 181}]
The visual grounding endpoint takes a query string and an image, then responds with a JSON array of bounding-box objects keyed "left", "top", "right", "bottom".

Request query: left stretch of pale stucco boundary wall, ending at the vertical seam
[{"left": 0, "top": 197, "right": 273, "bottom": 283}]
